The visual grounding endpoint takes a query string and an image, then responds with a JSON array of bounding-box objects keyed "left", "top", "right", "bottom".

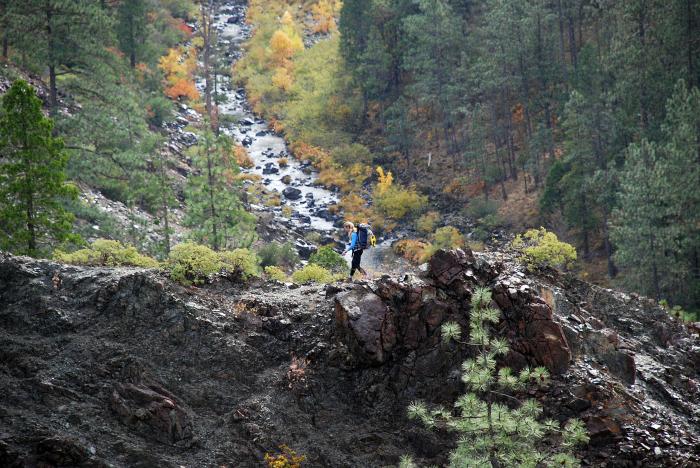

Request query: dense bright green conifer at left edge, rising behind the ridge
[{"left": 0, "top": 80, "right": 78, "bottom": 256}]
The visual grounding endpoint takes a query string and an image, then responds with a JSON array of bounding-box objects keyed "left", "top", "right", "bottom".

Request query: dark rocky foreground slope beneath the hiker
[{"left": 0, "top": 251, "right": 700, "bottom": 467}]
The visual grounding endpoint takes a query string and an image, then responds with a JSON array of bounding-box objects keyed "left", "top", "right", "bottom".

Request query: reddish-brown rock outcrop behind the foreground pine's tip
[{"left": 335, "top": 250, "right": 571, "bottom": 374}]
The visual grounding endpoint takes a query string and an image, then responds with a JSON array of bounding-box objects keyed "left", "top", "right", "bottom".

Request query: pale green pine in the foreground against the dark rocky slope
[{"left": 400, "top": 288, "right": 588, "bottom": 468}]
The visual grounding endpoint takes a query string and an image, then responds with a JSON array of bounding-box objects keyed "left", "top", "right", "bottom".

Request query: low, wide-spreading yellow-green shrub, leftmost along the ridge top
[{"left": 53, "top": 239, "right": 160, "bottom": 268}]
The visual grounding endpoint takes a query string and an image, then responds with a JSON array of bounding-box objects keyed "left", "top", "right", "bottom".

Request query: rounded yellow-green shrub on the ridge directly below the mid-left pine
[{"left": 166, "top": 242, "right": 223, "bottom": 285}]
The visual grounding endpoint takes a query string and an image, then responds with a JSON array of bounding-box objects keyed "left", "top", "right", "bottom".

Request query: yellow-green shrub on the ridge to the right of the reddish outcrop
[{"left": 511, "top": 227, "right": 576, "bottom": 269}]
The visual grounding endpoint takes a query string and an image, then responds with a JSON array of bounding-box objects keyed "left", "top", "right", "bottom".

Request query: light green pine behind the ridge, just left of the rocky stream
[{"left": 185, "top": 130, "right": 255, "bottom": 250}]
